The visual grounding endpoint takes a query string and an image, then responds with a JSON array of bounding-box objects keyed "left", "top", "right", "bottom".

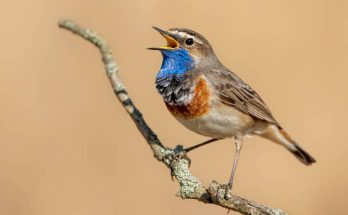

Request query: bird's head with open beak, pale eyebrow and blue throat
[{"left": 149, "top": 27, "right": 216, "bottom": 76}]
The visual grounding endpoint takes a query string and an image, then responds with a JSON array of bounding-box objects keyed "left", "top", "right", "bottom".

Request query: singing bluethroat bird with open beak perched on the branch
[{"left": 149, "top": 27, "right": 316, "bottom": 193}]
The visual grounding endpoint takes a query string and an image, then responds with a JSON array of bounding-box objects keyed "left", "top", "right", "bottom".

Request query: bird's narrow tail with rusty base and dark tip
[{"left": 261, "top": 125, "right": 316, "bottom": 165}]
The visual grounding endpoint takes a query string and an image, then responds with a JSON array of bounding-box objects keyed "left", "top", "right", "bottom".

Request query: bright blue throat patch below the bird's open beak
[{"left": 157, "top": 48, "right": 194, "bottom": 79}]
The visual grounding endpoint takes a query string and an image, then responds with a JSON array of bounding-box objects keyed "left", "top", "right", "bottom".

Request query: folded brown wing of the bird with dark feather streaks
[{"left": 207, "top": 68, "right": 280, "bottom": 127}]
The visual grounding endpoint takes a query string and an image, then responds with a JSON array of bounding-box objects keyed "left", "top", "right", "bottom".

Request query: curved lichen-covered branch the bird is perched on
[{"left": 59, "top": 20, "right": 286, "bottom": 215}]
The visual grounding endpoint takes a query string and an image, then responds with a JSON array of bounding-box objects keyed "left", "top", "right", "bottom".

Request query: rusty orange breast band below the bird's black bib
[{"left": 166, "top": 77, "right": 211, "bottom": 119}]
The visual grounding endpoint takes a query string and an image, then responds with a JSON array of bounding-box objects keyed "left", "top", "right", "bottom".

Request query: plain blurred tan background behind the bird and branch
[{"left": 0, "top": 0, "right": 348, "bottom": 215}]
